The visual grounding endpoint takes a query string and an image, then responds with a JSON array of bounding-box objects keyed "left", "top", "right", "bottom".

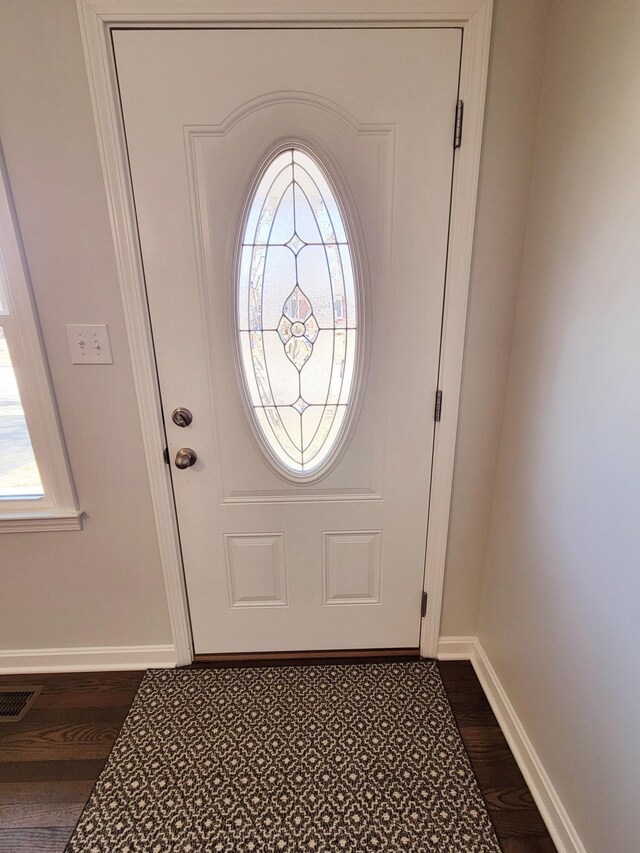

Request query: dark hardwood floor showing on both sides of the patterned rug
[{"left": 0, "top": 661, "right": 555, "bottom": 853}]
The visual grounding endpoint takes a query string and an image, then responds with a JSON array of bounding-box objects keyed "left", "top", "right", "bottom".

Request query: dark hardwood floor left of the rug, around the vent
[{"left": 0, "top": 672, "right": 143, "bottom": 853}]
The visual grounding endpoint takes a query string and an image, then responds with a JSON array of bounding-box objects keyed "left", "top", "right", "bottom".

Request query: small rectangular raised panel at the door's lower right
[{"left": 322, "top": 530, "right": 382, "bottom": 604}]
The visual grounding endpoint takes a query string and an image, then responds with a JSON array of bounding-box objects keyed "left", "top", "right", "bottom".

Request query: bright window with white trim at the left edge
[{"left": 0, "top": 154, "right": 81, "bottom": 532}]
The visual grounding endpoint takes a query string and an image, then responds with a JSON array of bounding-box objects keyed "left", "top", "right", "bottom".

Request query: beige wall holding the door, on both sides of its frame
[{"left": 0, "top": 0, "right": 548, "bottom": 649}]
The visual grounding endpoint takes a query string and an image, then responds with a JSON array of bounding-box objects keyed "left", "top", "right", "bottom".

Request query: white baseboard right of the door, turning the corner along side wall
[{"left": 438, "top": 637, "right": 587, "bottom": 853}]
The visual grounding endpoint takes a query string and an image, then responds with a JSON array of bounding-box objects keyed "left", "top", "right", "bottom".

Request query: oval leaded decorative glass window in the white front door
[{"left": 237, "top": 147, "right": 359, "bottom": 477}]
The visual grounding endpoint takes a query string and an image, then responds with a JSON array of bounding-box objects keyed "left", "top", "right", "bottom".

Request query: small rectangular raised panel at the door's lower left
[{"left": 224, "top": 533, "right": 287, "bottom": 607}]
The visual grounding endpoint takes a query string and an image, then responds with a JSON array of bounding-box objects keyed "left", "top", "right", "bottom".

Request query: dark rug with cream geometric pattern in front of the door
[{"left": 67, "top": 661, "right": 500, "bottom": 853}]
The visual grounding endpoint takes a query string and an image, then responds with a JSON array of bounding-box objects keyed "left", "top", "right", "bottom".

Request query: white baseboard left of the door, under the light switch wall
[{"left": 0, "top": 645, "right": 178, "bottom": 675}]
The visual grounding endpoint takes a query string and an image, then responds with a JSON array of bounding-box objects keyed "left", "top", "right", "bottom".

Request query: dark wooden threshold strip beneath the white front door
[{"left": 191, "top": 648, "right": 420, "bottom": 667}]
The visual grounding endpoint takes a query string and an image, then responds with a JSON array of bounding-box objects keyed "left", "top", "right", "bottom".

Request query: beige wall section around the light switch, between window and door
[{"left": 0, "top": 0, "right": 171, "bottom": 650}]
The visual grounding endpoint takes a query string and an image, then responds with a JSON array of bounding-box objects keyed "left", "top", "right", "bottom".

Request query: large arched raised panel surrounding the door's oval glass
[{"left": 185, "top": 99, "right": 396, "bottom": 504}]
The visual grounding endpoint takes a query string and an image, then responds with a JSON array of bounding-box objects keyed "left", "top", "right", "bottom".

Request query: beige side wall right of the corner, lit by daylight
[{"left": 479, "top": 0, "right": 640, "bottom": 853}]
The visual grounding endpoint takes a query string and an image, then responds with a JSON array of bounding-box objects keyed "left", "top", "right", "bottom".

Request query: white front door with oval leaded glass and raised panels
[{"left": 113, "top": 27, "right": 461, "bottom": 654}]
